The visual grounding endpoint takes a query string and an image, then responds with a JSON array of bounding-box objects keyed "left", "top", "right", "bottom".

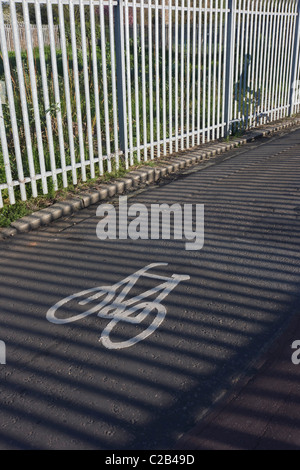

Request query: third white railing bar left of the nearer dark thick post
[{"left": 90, "top": 0, "right": 103, "bottom": 175}]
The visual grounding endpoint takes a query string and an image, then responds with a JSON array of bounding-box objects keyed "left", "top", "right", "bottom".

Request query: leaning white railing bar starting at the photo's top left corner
[{"left": 0, "top": 2, "right": 27, "bottom": 201}]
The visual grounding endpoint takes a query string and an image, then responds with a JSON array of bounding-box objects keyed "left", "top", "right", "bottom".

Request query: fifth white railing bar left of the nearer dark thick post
[{"left": 69, "top": 0, "right": 86, "bottom": 181}]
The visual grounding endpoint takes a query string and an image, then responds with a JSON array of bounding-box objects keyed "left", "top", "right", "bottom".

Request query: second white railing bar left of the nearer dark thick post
[{"left": 99, "top": 0, "right": 112, "bottom": 173}]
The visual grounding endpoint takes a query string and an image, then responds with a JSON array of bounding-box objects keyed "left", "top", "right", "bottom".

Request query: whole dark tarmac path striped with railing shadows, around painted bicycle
[{"left": 0, "top": 125, "right": 300, "bottom": 450}]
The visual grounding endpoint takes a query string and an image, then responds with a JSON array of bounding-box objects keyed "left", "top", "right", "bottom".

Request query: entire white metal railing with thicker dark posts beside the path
[{"left": 0, "top": 0, "right": 300, "bottom": 207}]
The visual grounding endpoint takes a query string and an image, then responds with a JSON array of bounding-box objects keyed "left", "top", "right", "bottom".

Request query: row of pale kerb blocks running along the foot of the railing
[{"left": 0, "top": 118, "right": 300, "bottom": 239}]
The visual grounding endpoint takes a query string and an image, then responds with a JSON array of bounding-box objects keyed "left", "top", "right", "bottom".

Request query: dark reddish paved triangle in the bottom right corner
[{"left": 176, "top": 306, "right": 300, "bottom": 451}]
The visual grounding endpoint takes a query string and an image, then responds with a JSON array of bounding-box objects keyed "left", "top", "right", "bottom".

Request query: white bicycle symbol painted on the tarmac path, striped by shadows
[{"left": 47, "top": 263, "right": 190, "bottom": 349}]
